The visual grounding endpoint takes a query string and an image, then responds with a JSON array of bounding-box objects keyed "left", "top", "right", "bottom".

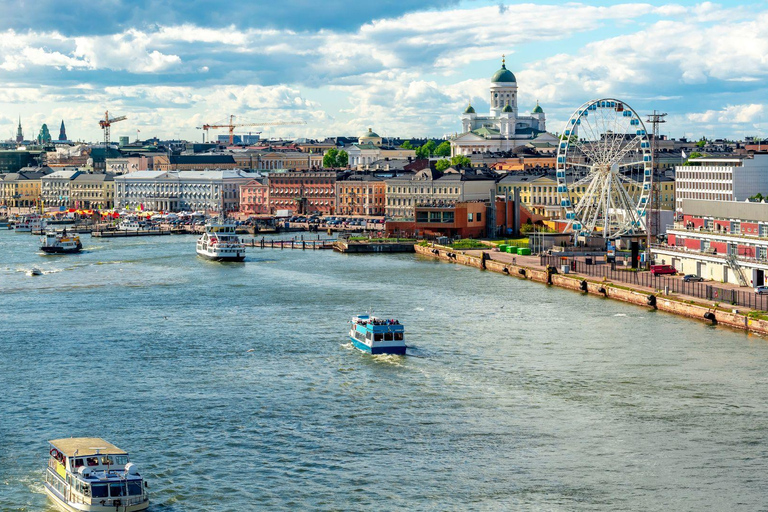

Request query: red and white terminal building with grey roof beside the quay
[{"left": 651, "top": 199, "right": 768, "bottom": 286}]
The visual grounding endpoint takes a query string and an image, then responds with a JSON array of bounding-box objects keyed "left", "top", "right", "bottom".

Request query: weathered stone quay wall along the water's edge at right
[{"left": 414, "top": 245, "right": 768, "bottom": 334}]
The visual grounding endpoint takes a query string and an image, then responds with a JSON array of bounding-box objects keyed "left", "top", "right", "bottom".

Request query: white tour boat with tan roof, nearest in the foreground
[{"left": 45, "top": 437, "right": 149, "bottom": 512}]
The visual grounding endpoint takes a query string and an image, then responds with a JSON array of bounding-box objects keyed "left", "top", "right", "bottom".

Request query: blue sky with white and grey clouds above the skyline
[{"left": 0, "top": 0, "right": 768, "bottom": 141}]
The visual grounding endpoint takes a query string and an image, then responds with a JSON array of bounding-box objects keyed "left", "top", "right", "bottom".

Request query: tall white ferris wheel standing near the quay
[{"left": 557, "top": 99, "right": 653, "bottom": 238}]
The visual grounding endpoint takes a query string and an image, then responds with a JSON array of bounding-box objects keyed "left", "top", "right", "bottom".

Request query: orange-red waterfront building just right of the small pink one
[{"left": 267, "top": 170, "right": 339, "bottom": 214}]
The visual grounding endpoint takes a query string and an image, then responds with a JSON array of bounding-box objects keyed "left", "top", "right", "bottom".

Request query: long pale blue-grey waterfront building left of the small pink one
[{"left": 115, "top": 169, "right": 261, "bottom": 212}]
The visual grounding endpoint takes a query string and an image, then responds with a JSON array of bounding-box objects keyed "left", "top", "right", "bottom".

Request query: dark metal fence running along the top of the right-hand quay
[{"left": 540, "top": 255, "right": 768, "bottom": 311}]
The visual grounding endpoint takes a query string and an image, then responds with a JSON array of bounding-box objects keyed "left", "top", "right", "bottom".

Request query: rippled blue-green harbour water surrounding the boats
[{"left": 0, "top": 231, "right": 768, "bottom": 511}]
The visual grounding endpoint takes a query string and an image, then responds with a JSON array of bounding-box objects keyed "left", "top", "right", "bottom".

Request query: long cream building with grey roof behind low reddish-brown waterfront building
[{"left": 385, "top": 168, "right": 496, "bottom": 220}]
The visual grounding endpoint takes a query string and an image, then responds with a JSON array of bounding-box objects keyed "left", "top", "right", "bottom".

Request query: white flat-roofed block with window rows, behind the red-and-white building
[{"left": 675, "top": 153, "right": 768, "bottom": 211}]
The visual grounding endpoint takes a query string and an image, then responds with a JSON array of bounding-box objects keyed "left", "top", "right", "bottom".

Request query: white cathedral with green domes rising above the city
[{"left": 451, "top": 58, "right": 557, "bottom": 156}]
